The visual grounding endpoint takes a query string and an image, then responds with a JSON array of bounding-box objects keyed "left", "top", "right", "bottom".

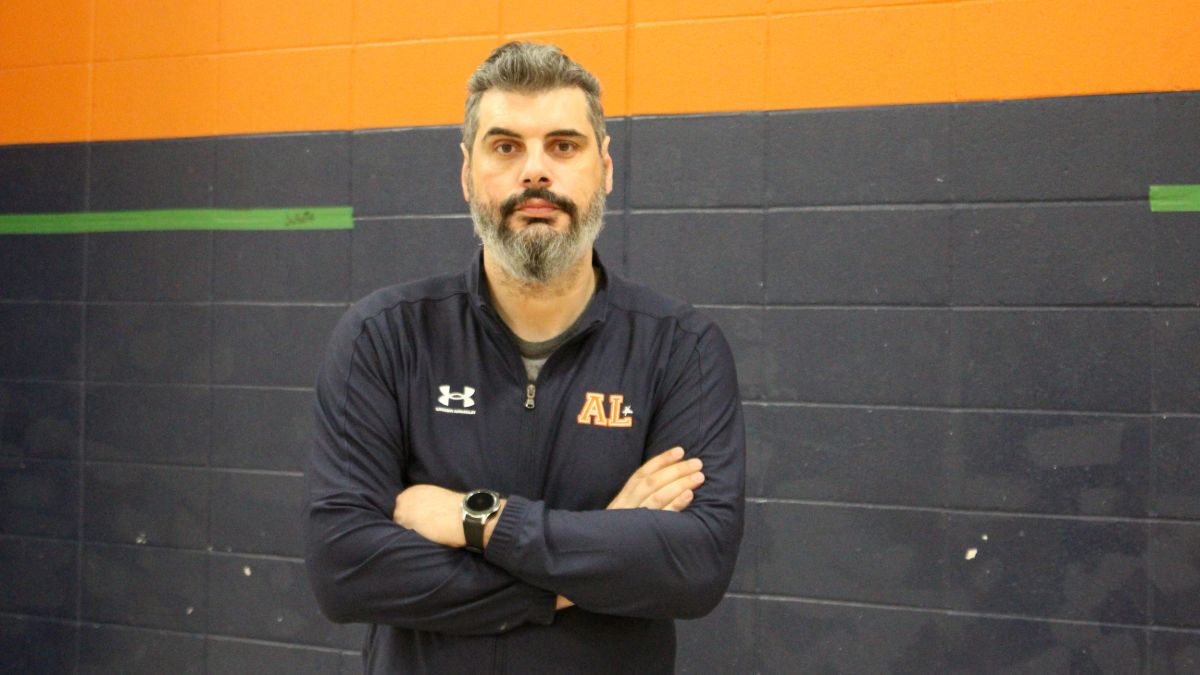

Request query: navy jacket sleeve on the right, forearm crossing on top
[{"left": 485, "top": 325, "right": 745, "bottom": 619}]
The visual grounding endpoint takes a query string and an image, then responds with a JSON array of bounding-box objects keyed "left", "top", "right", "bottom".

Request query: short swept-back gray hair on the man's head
[{"left": 462, "top": 42, "right": 605, "bottom": 153}]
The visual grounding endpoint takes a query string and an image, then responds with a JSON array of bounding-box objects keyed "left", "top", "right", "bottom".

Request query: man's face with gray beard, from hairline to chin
[{"left": 462, "top": 88, "right": 612, "bottom": 283}]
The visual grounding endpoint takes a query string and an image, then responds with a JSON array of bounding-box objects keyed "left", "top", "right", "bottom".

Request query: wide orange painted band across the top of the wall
[{"left": 0, "top": 0, "right": 1200, "bottom": 144}]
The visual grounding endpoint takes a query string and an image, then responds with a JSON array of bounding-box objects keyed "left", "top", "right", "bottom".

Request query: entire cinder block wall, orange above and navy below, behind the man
[{"left": 0, "top": 0, "right": 1200, "bottom": 673}]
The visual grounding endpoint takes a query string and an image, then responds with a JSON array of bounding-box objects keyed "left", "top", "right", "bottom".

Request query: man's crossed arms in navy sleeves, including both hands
[{"left": 306, "top": 312, "right": 744, "bottom": 634}]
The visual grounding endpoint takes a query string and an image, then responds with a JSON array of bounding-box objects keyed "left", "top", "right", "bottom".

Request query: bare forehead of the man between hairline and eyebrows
[{"left": 476, "top": 86, "right": 595, "bottom": 138}]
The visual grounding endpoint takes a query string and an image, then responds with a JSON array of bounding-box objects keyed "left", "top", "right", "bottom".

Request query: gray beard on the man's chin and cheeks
[{"left": 470, "top": 190, "right": 605, "bottom": 286}]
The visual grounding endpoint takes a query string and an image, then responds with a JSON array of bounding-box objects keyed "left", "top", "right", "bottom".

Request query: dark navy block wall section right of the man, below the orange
[{"left": 625, "top": 94, "right": 1200, "bottom": 673}]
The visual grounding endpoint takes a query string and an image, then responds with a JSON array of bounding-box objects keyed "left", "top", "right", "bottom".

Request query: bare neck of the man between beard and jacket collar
[{"left": 484, "top": 247, "right": 596, "bottom": 342}]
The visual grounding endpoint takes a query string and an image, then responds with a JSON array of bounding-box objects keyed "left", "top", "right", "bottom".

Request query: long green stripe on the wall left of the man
[{"left": 0, "top": 207, "right": 354, "bottom": 234}]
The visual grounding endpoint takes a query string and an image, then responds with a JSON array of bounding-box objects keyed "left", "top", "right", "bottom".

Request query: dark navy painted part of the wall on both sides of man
[{"left": 0, "top": 92, "right": 1200, "bottom": 674}]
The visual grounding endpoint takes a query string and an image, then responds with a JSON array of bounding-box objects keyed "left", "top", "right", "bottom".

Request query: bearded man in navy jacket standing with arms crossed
[{"left": 306, "top": 43, "right": 744, "bottom": 673}]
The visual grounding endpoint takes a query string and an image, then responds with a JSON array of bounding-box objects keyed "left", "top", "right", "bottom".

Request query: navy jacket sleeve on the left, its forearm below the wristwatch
[{"left": 305, "top": 310, "right": 554, "bottom": 634}]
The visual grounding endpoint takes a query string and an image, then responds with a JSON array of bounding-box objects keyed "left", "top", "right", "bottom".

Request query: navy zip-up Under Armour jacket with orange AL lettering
[{"left": 305, "top": 256, "right": 745, "bottom": 674}]
